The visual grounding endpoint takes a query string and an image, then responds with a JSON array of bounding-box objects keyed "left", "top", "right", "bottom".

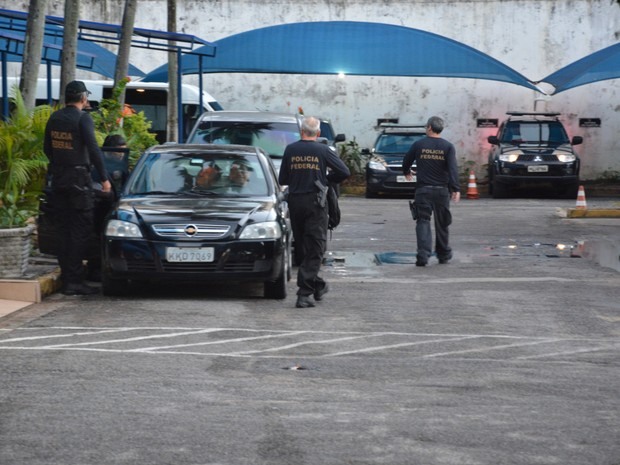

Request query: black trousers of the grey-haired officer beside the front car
[{"left": 288, "top": 193, "right": 328, "bottom": 295}]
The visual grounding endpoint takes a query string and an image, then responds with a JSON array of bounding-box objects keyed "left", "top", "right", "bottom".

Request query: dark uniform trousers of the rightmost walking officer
[{"left": 415, "top": 186, "right": 452, "bottom": 263}]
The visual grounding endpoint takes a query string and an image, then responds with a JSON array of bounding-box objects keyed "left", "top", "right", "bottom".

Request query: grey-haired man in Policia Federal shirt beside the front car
[{"left": 279, "top": 116, "right": 351, "bottom": 308}]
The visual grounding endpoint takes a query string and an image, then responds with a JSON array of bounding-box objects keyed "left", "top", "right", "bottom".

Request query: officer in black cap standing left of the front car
[{"left": 44, "top": 81, "right": 112, "bottom": 295}]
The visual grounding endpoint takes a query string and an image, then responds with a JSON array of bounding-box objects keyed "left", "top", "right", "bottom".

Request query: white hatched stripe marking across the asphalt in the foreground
[{"left": 0, "top": 327, "right": 620, "bottom": 361}]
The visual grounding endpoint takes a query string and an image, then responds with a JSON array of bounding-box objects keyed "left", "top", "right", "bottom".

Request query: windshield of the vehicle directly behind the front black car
[{"left": 188, "top": 121, "right": 300, "bottom": 157}]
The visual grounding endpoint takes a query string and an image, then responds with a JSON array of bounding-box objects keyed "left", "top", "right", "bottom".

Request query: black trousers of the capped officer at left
[{"left": 54, "top": 187, "right": 94, "bottom": 286}]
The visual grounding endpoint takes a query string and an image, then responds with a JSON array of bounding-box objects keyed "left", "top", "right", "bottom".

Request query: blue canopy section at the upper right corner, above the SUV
[{"left": 539, "top": 43, "right": 620, "bottom": 94}]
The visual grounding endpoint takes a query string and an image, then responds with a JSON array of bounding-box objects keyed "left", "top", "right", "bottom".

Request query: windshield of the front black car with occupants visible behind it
[{"left": 127, "top": 152, "right": 269, "bottom": 196}]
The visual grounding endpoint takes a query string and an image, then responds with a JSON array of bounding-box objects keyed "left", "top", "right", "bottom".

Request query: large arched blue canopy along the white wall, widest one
[{"left": 143, "top": 21, "right": 542, "bottom": 92}]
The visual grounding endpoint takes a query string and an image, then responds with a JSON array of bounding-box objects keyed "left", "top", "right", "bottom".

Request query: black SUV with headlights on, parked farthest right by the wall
[{"left": 488, "top": 111, "right": 583, "bottom": 198}]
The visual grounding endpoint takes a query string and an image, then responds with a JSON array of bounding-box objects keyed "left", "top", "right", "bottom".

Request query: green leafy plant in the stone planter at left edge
[{"left": 0, "top": 86, "right": 52, "bottom": 228}]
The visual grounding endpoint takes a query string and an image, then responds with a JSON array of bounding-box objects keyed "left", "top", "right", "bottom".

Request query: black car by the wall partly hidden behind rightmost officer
[{"left": 362, "top": 123, "right": 426, "bottom": 198}]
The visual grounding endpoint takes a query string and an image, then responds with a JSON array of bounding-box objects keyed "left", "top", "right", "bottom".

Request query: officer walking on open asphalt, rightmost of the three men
[{"left": 402, "top": 116, "right": 461, "bottom": 266}]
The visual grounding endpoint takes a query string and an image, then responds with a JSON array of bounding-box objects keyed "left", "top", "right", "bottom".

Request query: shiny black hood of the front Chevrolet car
[{"left": 116, "top": 196, "right": 275, "bottom": 224}]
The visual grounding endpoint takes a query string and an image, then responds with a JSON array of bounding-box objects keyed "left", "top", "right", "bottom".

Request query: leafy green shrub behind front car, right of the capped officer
[{"left": 92, "top": 78, "right": 157, "bottom": 167}]
